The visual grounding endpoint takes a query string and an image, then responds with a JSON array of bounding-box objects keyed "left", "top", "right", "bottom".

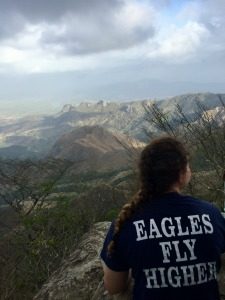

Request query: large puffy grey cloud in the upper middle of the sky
[{"left": 41, "top": 11, "right": 154, "bottom": 54}]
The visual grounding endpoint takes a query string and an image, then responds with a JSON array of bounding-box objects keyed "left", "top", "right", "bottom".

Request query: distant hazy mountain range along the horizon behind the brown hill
[{"left": 0, "top": 93, "right": 225, "bottom": 158}]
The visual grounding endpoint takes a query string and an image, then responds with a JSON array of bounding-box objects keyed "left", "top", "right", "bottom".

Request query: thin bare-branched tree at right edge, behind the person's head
[{"left": 144, "top": 95, "right": 225, "bottom": 209}]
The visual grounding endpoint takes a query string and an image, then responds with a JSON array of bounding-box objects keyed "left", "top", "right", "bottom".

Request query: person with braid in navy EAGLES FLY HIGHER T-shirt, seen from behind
[{"left": 100, "top": 137, "right": 225, "bottom": 300}]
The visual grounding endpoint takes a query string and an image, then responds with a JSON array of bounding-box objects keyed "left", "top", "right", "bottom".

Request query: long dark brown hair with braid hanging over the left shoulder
[{"left": 108, "top": 137, "right": 188, "bottom": 255}]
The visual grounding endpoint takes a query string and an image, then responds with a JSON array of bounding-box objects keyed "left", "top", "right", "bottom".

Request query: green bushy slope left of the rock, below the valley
[{"left": 0, "top": 172, "right": 125, "bottom": 300}]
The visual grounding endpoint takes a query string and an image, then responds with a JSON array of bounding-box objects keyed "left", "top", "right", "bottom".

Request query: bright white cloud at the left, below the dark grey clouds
[{"left": 0, "top": 23, "right": 99, "bottom": 73}]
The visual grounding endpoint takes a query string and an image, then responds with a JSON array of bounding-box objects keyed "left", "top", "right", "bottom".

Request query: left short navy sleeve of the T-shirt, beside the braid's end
[{"left": 100, "top": 222, "right": 129, "bottom": 272}]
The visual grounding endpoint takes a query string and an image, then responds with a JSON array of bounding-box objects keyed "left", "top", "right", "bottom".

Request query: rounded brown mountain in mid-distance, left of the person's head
[{"left": 48, "top": 126, "right": 144, "bottom": 172}]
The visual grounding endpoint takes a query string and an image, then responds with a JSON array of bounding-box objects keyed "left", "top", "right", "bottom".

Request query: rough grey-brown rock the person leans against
[{"left": 33, "top": 222, "right": 225, "bottom": 300}]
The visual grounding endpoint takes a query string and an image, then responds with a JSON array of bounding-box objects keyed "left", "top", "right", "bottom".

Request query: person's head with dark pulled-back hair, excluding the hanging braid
[{"left": 139, "top": 137, "right": 191, "bottom": 197}]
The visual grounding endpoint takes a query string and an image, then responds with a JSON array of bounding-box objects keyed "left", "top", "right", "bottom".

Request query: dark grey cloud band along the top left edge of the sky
[{"left": 0, "top": 0, "right": 121, "bottom": 39}]
